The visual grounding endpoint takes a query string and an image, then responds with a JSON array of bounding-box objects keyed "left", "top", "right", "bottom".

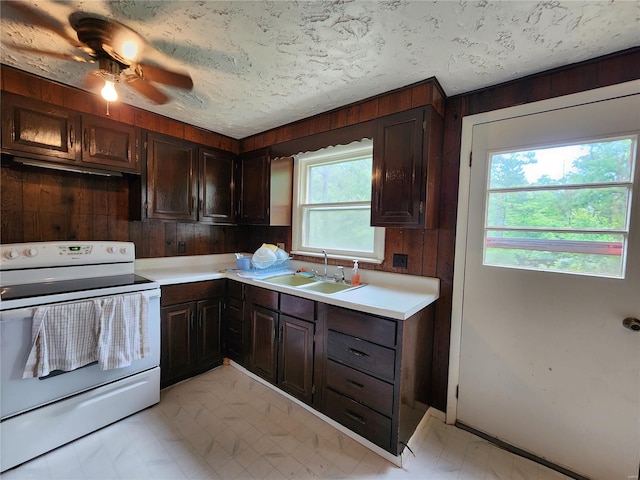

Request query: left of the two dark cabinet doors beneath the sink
[{"left": 249, "top": 305, "right": 278, "bottom": 384}]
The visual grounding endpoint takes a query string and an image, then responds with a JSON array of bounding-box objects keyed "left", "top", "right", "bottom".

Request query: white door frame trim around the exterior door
[{"left": 445, "top": 80, "right": 640, "bottom": 425}]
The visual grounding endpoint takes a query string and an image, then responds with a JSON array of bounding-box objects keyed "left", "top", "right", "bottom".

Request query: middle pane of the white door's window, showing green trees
[{"left": 486, "top": 187, "right": 629, "bottom": 230}]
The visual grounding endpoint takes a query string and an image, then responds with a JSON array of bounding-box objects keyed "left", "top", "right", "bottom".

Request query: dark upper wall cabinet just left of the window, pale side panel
[{"left": 237, "top": 149, "right": 293, "bottom": 226}]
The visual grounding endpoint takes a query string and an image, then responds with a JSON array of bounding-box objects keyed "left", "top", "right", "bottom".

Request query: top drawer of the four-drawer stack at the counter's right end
[{"left": 325, "top": 305, "right": 397, "bottom": 347}]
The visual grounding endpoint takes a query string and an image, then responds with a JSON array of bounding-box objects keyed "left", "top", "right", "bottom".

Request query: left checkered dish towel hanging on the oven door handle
[{"left": 22, "top": 301, "right": 97, "bottom": 378}]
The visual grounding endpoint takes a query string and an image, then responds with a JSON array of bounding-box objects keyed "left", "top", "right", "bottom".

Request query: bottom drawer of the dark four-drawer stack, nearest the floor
[{"left": 325, "top": 388, "right": 391, "bottom": 451}]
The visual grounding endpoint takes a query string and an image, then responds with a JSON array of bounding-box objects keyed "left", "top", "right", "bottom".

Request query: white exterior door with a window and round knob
[{"left": 457, "top": 90, "right": 640, "bottom": 480}]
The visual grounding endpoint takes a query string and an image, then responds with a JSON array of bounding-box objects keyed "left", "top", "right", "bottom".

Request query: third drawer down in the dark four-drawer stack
[{"left": 327, "top": 360, "right": 393, "bottom": 416}]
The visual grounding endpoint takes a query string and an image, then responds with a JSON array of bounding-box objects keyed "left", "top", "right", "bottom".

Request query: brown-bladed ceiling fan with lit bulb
[{"left": 3, "top": 1, "right": 193, "bottom": 105}]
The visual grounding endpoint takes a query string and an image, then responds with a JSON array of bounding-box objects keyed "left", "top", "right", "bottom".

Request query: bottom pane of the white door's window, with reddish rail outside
[{"left": 484, "top": 230, "right": 625, "bottom": 278}]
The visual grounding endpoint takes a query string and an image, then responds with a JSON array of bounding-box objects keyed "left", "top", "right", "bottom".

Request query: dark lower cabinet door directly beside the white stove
[{"left": 160, "top": 303, "right": 196, "bottom": 387}]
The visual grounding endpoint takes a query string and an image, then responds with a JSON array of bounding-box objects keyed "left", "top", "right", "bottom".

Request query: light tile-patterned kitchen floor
[{"left": 2, "top": 366, "right": 568, "bottom": 480}]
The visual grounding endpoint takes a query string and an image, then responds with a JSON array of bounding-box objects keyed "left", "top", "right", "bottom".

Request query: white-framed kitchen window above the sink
[{"left": 293, "top": 139, "right": 384, "bottom": 263}]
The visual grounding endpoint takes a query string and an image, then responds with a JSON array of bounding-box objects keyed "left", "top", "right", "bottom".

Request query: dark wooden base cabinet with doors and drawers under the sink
[{"left": 226, "top": 281, "right": 435, "bottom": 455}]
